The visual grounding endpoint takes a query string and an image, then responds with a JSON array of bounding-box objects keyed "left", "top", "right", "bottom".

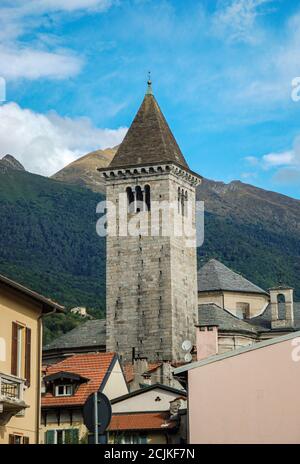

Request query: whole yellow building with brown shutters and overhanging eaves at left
[{"left": 0, "top": 275, "right": 64, "bottom": 444}]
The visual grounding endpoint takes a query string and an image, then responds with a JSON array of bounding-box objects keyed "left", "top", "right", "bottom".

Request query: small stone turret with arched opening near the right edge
[{"left": 269, "top": 286, "right": 294, "bottom": 329}]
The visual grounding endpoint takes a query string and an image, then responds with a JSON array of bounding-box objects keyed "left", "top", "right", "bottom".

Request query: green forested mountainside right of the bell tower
[{"left": 198, "top": 213, "right": 300, "bottom": 301}]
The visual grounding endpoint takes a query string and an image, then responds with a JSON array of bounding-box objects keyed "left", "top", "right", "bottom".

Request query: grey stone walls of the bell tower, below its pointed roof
[{"left": 106, "top": 165, "right": 197, "bottom": 361}]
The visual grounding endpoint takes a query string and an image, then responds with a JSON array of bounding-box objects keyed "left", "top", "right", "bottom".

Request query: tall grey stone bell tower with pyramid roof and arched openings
[{"left": 99, "top": 80, "right": 201, "bottom": 361}]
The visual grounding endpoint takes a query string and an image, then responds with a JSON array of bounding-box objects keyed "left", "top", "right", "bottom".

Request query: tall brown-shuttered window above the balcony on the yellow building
[{"left": 11, "top": 322, "right": 31, "bottom": 387}]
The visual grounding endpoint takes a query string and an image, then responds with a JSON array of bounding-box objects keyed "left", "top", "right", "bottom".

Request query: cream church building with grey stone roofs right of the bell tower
[{"left": 196, "top": 259, "right": 300, "bottom": 359}]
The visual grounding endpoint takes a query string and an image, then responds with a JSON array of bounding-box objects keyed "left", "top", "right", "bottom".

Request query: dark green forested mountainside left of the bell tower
[{"left": 0, "top": 170, "right": 105, "bottom": 342}]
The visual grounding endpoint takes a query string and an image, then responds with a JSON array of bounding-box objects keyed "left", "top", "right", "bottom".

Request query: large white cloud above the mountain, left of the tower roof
[{"left": 0, "top": 103, "right": 127, "bottom": 176}]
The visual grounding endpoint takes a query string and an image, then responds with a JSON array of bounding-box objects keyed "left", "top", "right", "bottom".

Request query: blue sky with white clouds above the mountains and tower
[{"left": 0, "top": 0, "right": 300, "bottom": 198}]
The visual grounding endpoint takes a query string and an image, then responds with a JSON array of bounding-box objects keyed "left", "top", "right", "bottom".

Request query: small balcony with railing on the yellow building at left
[{"left": 0, "top": 372, "right": 28, "bottom": 425}]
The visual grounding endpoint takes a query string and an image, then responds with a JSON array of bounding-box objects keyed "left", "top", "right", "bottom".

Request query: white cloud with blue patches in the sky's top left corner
[{"left": 0, "top": 0, "right": 114, "bottom": 79}]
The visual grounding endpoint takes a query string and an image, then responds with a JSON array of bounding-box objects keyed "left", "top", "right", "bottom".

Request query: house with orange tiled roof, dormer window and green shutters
[{"left": 41, "top": 353, "right": 128, "bottom": 444}]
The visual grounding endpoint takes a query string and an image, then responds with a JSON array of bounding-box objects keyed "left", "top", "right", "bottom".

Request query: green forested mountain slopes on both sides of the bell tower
[{"left": 0, "top": 170, "right": 300, "bottom": 343}]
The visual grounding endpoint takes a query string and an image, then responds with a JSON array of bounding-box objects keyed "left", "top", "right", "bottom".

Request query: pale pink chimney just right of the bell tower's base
[{"left": 196, "top": 325, "right": 218, "bottom": 361}]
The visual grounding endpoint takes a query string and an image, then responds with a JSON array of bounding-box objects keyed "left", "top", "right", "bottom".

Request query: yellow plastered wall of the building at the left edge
[{"left": 0, "top": 289, "right": 41, "bottom": 444}]
